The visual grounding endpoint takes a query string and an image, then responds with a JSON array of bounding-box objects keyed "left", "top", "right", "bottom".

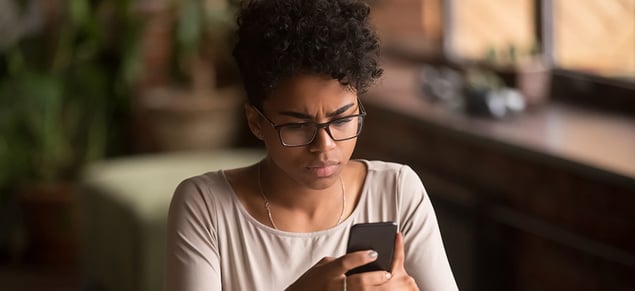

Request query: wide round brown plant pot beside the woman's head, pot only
[{"left": 140, "top": 87, "right": 243, "bottom": 151}]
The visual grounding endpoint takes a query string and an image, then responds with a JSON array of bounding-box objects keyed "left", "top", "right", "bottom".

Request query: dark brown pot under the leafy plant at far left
[{"left": 18, "top": 182, "right": 78, "bottom": 266}]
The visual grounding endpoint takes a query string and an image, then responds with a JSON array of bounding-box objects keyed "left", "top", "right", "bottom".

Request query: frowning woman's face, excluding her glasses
[{"left": 253, "top": 75, "right": 360, "bottom": 190}]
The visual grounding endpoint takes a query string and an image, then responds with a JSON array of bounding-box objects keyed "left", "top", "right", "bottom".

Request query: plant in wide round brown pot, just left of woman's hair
[{"left": 138, "top": 0, "right": 243, "bottom": 150}]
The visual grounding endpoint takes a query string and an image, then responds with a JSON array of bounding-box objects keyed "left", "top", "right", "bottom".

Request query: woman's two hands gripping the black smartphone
[{"left": 287, "top": 233, "right": 419, "bottom": 291}]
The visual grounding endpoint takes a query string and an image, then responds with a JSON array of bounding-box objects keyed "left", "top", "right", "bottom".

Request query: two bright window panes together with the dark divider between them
[{"left": 444, "top": 0, "right": 635, "bottom": 81}]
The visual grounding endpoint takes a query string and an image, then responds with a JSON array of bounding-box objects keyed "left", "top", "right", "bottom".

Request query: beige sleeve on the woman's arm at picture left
[{"left": 164, "top": 179, "right": 222, "bottom": 291}]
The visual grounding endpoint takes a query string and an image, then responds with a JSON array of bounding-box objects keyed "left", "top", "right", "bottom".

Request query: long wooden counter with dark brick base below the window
[{"left": 356, "top": 57, "right": 635, "bottom": 290}]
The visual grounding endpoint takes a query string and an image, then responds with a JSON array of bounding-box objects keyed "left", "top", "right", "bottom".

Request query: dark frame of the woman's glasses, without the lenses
[{"left": 252, "top": 98, "right": 366, "bottom": 147}]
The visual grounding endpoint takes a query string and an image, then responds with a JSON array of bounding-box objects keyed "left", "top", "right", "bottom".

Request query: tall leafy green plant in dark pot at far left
[{"left": 0, "top": 0, "right": 138, "bottom": 264}]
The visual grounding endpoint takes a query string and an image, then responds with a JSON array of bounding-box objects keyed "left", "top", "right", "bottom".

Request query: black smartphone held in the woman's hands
[{"left": 346, "top": 222, "right": 397, "bottom": 276}]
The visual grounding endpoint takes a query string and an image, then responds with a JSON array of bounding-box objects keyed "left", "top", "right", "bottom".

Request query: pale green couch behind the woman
[{"left": 79, "top": 149, "right": 264, "bottom": 291}]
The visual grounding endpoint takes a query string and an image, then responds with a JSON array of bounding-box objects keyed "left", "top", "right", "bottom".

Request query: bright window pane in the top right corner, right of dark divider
[{"left": 545, "top": 0, "right": 635, "bottom": 80}]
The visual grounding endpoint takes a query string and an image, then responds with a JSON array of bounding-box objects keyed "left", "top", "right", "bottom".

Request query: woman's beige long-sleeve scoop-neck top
[{"left": 165, "top": 160, "right": 458, "bottom": 291}]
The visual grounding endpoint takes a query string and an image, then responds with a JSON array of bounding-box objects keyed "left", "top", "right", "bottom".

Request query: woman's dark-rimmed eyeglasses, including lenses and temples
[{"left": 254, "top": 100, "right": 366, "bottom": 147}]
